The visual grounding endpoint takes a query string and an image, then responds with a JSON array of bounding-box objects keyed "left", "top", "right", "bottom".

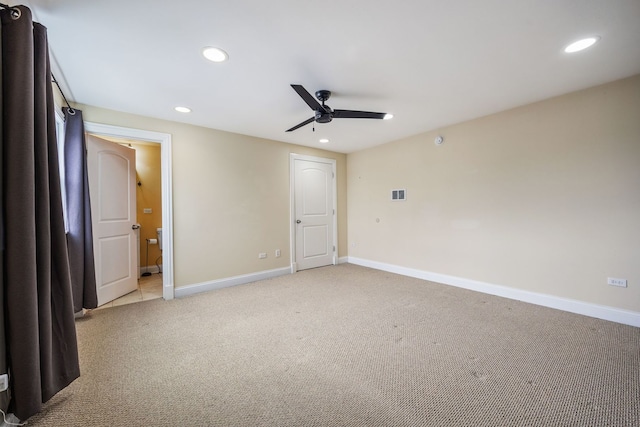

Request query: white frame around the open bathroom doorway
[{"left": 84, "top": 122, "right": 175, "bottom": 300}]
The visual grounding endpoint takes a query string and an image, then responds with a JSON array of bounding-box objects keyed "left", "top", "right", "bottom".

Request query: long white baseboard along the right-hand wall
[{"left": 347, "top": 257, "right": 640, "bottom": 327}]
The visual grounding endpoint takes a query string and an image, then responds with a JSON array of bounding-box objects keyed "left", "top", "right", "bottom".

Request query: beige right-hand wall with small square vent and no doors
[{"left": 347, "top": 76, "right": 640, "bottom": 311}]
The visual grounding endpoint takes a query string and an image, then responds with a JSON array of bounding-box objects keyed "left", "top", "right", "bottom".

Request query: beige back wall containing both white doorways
[{"left": 73, "top": 105, "right": 347, "bottom": 287}]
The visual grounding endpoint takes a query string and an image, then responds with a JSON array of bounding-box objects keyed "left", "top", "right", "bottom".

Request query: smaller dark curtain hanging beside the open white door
[{"left": 63, "top": 108, "right": 98, "bottom": 313}]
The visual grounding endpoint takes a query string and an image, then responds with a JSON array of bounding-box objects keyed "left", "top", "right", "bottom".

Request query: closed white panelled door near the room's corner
[{"left": 293, "top": 158, "right": 336, "bottom": 270}]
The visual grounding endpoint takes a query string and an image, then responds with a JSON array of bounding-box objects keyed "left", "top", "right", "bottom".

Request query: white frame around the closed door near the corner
[{"left": 289, "top": 153, "right": 338, "bottom": 274}]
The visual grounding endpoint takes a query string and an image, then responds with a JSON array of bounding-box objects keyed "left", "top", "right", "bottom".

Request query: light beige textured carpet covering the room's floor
[{"left": 23, "top": 264, "right": 640, "bottom": 427}]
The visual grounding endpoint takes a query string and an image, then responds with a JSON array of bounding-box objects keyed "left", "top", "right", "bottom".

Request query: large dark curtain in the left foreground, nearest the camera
[{"left": 0, "top": 6, "right": 80, "bottom": 420}]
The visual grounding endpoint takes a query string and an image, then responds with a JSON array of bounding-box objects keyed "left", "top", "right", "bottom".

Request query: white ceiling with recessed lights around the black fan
[{"left": 25, "top": 0, "right": 640, "bottom": 153}]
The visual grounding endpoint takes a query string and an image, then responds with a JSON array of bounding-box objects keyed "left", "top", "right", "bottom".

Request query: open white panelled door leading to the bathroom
[{"left": 87, "top": 135, "right": 138, "bottom": 305}]
